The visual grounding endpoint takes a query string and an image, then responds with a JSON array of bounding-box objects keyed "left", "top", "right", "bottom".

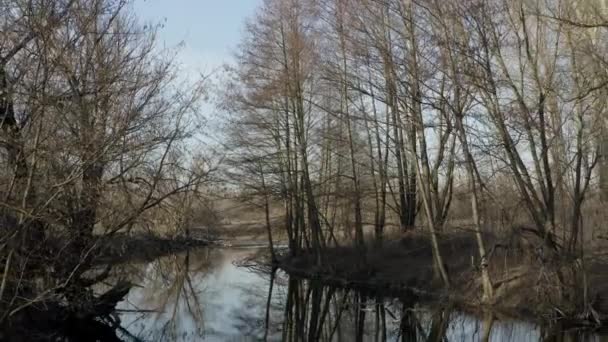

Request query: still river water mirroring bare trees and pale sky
[{"left": 108, "top": 248, "right": 608, "bottom": 341}]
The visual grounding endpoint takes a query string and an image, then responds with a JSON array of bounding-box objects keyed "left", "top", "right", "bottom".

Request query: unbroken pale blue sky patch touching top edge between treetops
[{"left": 134, "top": 0, "right": 262, "bottom": 74}]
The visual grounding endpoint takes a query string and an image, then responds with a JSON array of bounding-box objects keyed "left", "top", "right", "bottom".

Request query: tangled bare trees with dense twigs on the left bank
[{"left": 0, "top": 0, "right": 209, "bottom": 318}]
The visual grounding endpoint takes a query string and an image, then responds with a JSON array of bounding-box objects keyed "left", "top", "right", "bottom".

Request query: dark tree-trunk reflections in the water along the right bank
[{"left": 275, "top": 279, "right": 602, "bottom": 342}]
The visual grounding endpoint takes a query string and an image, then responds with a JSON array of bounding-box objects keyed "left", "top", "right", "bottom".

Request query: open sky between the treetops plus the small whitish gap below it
[{"left": 133, "top": 0, "right": 263, "bottom": 149}]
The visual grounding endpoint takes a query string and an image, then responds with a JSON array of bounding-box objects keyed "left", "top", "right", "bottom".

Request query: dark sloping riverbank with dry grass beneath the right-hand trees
[{"left": 277, "top": 233, "right": 608, "bottom": 327}]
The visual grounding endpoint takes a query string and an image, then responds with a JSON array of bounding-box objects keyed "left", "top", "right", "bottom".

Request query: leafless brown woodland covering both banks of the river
[{"left": 0, "top": 0, "right": 608, "bottom": 340}]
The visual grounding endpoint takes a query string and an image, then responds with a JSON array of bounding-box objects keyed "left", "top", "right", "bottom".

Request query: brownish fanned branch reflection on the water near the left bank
[{"left": 113, "top": 249, "right": 216, "bottom": 341}]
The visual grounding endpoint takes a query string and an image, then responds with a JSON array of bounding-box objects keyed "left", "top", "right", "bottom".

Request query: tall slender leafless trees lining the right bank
[{"left": 222, "top": 0, "right": 608, "bottom": 300}]
